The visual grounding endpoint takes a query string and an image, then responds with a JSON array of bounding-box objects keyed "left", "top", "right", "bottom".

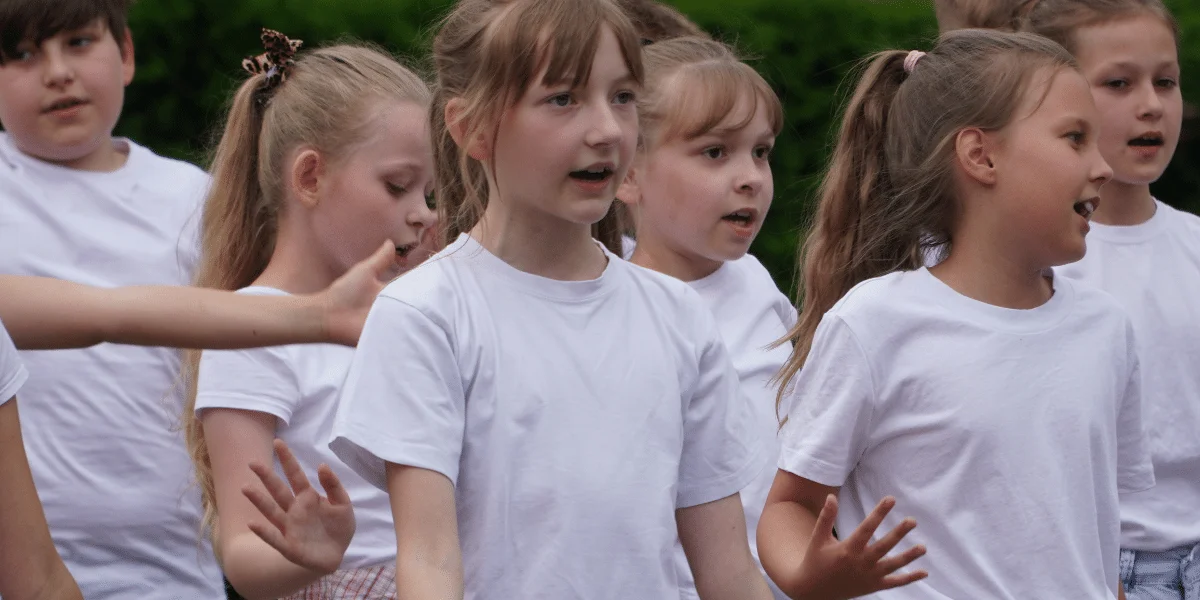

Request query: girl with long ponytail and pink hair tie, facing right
[{"left": 758, "top": 30, "right": 1154, "bottom": 599}]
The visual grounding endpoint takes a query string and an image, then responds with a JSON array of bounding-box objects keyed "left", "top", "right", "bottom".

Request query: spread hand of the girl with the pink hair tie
[{"left": 799, "top": 494, "right": 929, "bottom": 600}]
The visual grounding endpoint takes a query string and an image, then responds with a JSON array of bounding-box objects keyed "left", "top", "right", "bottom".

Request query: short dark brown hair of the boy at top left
[{"left": 0, "top": 0, "right": 132, "bottom": 65}]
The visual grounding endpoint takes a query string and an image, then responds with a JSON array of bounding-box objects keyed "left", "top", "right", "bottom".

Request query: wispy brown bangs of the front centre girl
[{"left": 480, "top": 0, "right": 644, "bottom": 107}]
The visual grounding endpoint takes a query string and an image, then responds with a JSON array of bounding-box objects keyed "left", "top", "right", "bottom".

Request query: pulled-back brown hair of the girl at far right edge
[{"left": 1020, "top": 0, "right": 1180, "bottom": 54}]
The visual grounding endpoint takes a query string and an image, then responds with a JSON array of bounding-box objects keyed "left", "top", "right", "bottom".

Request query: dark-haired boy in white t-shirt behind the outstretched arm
[{"left": 0, "top": 0, "right": 223, "bottom": 600}]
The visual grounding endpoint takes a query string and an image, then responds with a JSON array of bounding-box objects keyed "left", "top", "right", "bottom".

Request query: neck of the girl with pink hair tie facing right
[{"left": 930, "top": 231, "right": 1054, "bottom": 310}]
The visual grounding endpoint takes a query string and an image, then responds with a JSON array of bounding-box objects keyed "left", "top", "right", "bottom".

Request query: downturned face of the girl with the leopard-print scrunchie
[{"left": 310, "top": 103, "right": 437, "bottom": 277}]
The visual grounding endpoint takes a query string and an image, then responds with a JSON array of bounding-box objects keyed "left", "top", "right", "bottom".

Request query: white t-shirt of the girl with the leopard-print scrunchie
[{"left": 196, "top": 287, "right": 396, "bottom": 569}]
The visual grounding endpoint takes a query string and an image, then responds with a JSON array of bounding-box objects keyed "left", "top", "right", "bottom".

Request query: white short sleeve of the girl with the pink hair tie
[{"left": 779, "top": 314, "right": 876, "bottom": 487}]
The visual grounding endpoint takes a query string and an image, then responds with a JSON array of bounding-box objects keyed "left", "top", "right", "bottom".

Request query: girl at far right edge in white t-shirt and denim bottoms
[{"left": 1028, "top": 0, "right": 1200, "bottom": 600}]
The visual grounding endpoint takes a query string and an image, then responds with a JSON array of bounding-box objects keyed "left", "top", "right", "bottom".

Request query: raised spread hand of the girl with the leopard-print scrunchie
[{"left": 241, "top": 439, "right": 354, "bottom": 575}]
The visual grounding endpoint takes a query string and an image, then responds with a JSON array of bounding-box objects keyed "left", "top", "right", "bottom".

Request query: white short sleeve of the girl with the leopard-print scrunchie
[{"left": 196, "top": 346, "right": 301, "bottom": 424}]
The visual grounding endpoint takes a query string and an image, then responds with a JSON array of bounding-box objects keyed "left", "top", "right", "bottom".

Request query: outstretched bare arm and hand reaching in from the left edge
[{"left": 0, "top": 244, "right": 395, "bottom": 349}]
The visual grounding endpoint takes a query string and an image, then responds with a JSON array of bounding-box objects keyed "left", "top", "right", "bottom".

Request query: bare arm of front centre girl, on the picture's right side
[{"left": 676, "top": 494, "right": 772, "bottom": 600}]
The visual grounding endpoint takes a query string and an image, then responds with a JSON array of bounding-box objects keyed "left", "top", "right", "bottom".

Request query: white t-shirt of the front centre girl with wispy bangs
[{"left": 332, "top": 235, "right": 768, "bottom": 600}]
